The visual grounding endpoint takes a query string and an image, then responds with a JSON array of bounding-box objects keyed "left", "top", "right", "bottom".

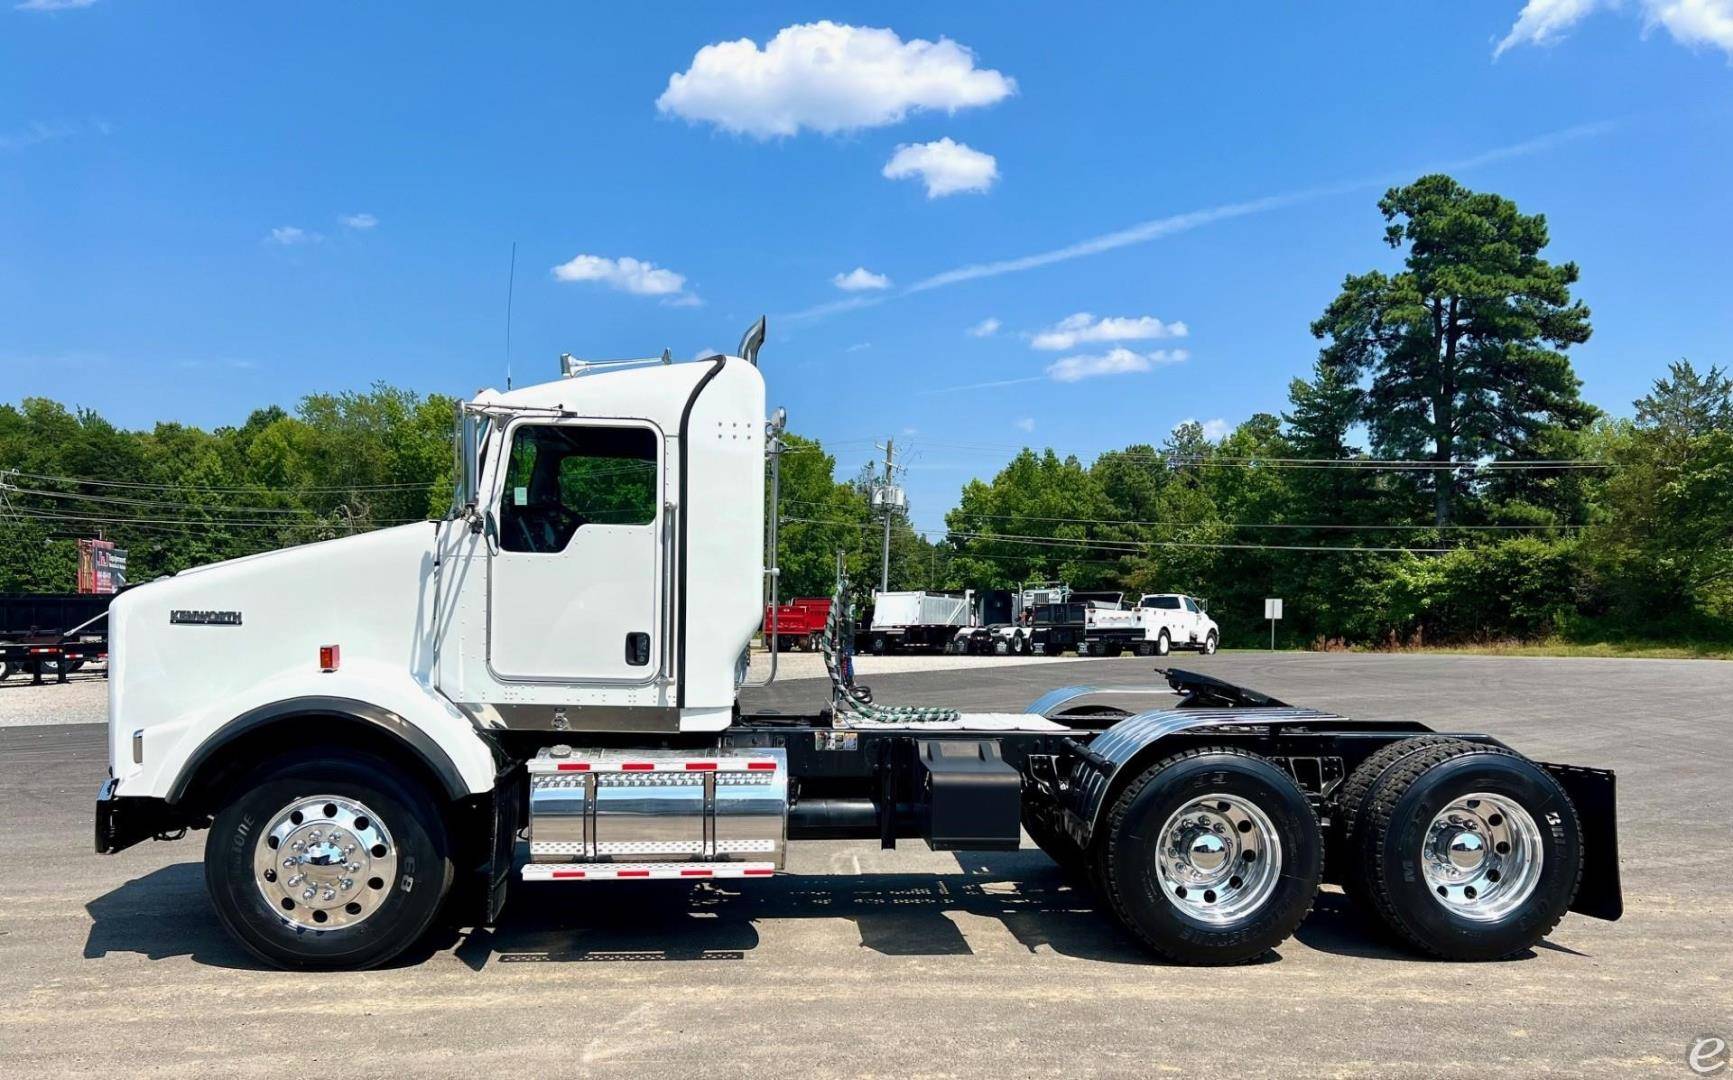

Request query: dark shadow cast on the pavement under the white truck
[{"left": 83, "top": 851, "right": 1545, "bottom": 971}]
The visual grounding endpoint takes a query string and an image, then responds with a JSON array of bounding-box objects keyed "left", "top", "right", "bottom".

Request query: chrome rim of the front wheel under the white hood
[{"left": 253, "top": 796, "right": 397, "bottom": 931}]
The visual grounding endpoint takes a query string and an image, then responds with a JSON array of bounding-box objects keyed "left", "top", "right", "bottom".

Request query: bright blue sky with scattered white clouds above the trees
[{"left": 0, "top": 0, "right": 1733, "bottom": 527}]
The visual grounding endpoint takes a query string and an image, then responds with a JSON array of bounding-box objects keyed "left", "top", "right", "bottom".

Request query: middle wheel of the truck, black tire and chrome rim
[{"left": 1095, "top": 747, "right": 1324, "bottom": 964}]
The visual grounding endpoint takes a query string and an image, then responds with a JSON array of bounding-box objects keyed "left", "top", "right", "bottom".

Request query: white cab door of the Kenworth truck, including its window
[{"left": 487, "top": 420, "right": 669, "bottom": 685}]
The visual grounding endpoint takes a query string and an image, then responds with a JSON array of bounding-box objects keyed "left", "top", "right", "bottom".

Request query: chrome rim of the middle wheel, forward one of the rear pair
[{"left": 1156, "top": 794, "right": 1282, "bottom": 924}]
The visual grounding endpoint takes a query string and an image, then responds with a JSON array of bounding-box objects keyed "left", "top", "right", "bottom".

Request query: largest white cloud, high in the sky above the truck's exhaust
[{"left": 655, "top": 21, "right": 1017, "bottom": 139}]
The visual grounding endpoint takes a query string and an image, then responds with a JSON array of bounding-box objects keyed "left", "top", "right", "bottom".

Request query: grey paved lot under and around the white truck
[{"left": 0, "top": 654, "right": 1733, "bottom": 1080}]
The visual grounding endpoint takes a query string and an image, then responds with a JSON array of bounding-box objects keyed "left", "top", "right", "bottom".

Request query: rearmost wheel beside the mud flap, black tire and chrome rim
[{"left": 1353, "top": 742, "right": 1582, "bottom": 960}]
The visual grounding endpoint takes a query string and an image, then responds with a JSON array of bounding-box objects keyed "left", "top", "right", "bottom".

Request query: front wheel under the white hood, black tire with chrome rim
[{"left": 204, "top": 751, "right": 452, "bottom": 971}]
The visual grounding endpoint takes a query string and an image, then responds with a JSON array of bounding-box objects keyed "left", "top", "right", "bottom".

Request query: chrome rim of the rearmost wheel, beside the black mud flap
[{"left": 1419, "top": 792, "right": 1544, "bottom": 922}]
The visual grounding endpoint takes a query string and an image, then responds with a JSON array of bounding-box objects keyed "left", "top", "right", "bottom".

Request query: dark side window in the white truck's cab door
[{"left": 499, "top": 423, "right": 660, "bottom": 555}]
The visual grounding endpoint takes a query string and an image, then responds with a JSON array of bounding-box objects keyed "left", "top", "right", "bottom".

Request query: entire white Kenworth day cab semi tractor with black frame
[{"left": 95, "top": 321, "right": 1620, "bottom": 969}]
